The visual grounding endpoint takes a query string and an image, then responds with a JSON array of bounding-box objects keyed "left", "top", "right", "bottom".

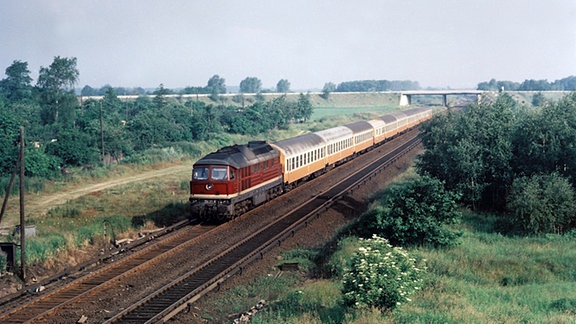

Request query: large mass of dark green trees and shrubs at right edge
[{"left": 417, "top": 93, "right": 576, "bottom": 233}]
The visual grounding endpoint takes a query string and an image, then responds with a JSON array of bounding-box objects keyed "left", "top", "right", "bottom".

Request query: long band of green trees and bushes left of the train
[{"left": 0, "top": 57, "right": 312, "bottom": 178}]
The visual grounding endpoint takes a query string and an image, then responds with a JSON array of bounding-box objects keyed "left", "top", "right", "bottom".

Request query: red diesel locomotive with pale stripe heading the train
[{"left": 190, "top": 141, "right": 282, "bottom": 221}]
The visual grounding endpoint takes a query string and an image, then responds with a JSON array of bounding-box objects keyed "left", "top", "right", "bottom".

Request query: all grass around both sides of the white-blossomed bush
[{"left": 196, "top": 212, "right": 576, "bottom": 323}]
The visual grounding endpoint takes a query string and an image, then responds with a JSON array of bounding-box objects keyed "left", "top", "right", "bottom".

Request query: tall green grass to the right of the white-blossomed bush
[{"left": 395, "top": 214, "right": 576, "bottom": 323}]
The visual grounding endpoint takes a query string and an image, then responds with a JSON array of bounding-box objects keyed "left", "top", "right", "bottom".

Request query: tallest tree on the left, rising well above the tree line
[{"left": 36, "top": 56, "right": 80, "bottom": 124}]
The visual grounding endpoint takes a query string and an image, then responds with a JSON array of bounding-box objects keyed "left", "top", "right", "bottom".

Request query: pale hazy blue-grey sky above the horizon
[{"left": 0, "top": 0, "right": 576, "bottom": 90}]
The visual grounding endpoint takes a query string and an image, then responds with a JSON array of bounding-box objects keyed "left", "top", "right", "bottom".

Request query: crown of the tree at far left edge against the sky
[{"left": 0, "top": 61, "right": 32, "bottom": 101}]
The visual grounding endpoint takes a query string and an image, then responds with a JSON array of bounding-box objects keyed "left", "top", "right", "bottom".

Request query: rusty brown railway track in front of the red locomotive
[{"left": 0, "top": 221, "right": 213, "bottom": 323}]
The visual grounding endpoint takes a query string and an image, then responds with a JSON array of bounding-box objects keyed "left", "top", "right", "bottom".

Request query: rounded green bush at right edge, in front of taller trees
[{"left": 507, "top": 173, "right": 576, "bottom": 234}]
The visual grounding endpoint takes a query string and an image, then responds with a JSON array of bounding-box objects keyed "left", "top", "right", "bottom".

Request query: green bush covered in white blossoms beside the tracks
[{"left": 342, "top": 235, "right": 425, "bottom": 311}]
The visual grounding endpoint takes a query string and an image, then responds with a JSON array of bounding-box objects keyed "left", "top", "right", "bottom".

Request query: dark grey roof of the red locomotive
[{"left": 194, "top": 141, "right": 280, "bottom": 169}]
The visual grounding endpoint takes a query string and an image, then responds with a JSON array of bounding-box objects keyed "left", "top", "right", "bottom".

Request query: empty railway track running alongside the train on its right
[{"left": 106, "top": 132, "right": 420, "bottom": 323}]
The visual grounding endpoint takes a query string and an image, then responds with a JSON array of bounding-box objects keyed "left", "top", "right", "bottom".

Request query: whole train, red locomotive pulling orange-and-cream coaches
[{"left": 189, "top": 107, "right": 440, "bottom": 222}]
